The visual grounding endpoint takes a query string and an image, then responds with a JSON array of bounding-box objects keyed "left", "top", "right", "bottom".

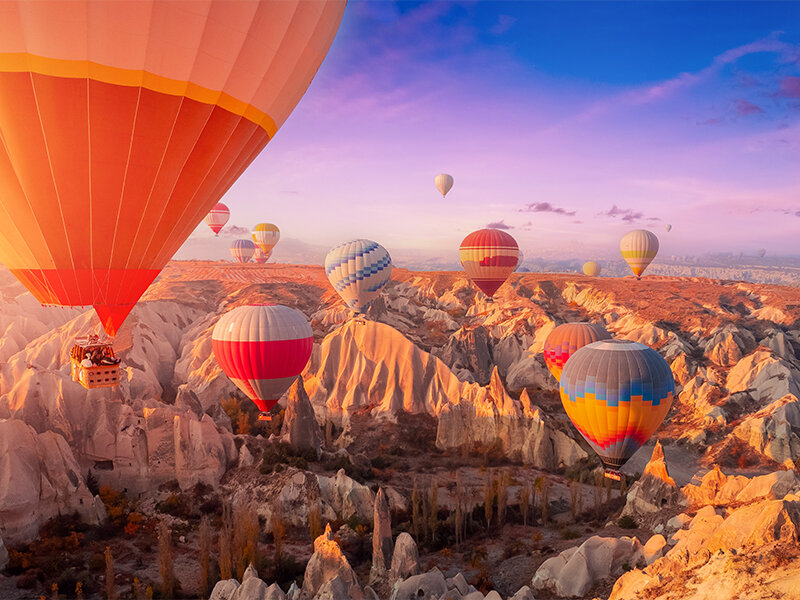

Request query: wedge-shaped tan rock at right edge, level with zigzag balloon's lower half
[{"left": 733, "top": 394, "right": 800, "bottom": 469}]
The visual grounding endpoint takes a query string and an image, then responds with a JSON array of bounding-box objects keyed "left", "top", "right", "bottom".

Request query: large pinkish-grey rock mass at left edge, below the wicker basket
[{"left": 0, "top": 419, "right": 104, "bottom": 544}]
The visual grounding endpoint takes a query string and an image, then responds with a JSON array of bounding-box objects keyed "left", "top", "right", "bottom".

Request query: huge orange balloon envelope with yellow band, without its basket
[{"left": 0, "top": 0, "right": 345, "bottom": 335}]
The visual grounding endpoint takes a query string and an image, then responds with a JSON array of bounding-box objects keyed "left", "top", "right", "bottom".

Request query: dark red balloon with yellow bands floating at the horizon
[{"left": 459, "top": 229, "right": 519, "bottom": 298}]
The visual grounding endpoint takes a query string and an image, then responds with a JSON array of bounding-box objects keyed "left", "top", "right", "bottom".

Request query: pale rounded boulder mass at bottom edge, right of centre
[{"left": 531, "top": 536, "right": 643, "bottom": 598}]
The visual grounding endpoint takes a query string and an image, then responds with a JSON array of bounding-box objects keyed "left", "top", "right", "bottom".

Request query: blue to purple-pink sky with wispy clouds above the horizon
[{"left": 176, "top": 0, "right": 800, "bottom": 266}]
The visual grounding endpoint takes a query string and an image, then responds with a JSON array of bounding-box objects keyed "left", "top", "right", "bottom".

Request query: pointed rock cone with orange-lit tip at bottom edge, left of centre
[{"left": 300, "top": 524, "right": 364, "bottom": 600}]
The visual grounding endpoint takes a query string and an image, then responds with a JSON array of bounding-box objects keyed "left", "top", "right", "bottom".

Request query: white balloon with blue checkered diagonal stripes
[{"left": 325, "top": 240, "right": 392, "bottom": 312}]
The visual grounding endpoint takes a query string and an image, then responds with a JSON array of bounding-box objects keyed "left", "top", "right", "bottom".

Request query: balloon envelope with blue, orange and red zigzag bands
[{"left": 560, "top": 340, "right": 675, "bottom": 469}]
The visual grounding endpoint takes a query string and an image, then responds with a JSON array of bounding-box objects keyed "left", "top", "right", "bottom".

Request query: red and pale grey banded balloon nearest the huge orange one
[{"left": 211, "top": 304, "right": 314, "bottom": 413}]
